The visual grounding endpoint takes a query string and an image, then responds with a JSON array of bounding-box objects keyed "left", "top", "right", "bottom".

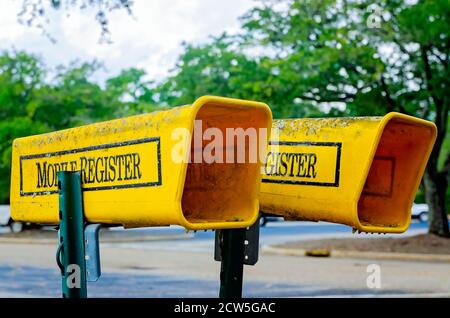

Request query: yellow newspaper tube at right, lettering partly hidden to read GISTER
[{"left": 260, "top": 113, "right": 437, "bottom": 233}]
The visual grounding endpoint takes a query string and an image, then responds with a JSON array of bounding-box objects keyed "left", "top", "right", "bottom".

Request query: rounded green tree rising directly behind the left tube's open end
[{"left": 155, "top": 34, "right": 321, "bottom": 117}]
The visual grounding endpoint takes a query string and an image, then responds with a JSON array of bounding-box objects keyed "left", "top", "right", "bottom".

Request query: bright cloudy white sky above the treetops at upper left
[{"left": 0, "top": 0, "right": 256, "bottom": 81}]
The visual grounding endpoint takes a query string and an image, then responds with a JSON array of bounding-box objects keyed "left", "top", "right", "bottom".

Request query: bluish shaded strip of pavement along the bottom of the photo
[{"left": 0, "top": 266, "right": 428, "bottom": 298}]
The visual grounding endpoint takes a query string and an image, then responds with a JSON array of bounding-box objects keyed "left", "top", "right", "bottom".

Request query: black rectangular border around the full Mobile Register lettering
[{"left": 20, "top": 137, "right": 162, "bottom": 197}]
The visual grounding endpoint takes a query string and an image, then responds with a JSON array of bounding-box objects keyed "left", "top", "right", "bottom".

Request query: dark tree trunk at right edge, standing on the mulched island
[{"left": 423, "top": 168, "right": 450, "bottom": 237}]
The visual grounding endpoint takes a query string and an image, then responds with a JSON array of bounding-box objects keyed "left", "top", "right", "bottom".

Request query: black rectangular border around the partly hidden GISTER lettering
[{"left": 262, "top": 141, "right": 342, "bottom": 187}]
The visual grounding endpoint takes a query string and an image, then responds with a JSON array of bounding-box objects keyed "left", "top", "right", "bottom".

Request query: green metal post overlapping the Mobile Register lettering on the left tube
[{"left": 56, "top": 171, "right": 87, "bottom": 298}]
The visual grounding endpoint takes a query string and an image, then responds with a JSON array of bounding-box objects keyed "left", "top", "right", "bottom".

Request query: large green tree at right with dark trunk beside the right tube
[{"left": 243, "top": 0, "right": 450, "bottom": 236}]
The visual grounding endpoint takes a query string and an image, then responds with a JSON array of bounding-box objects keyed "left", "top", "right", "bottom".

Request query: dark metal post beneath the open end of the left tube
[{"left": 219, "top": 229, "right": 246, "bottom": 298}]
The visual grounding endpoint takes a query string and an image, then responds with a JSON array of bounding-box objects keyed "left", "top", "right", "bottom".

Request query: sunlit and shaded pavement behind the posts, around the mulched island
[{"left": 0, "top": 222, "right": 450, "bottom": 297}]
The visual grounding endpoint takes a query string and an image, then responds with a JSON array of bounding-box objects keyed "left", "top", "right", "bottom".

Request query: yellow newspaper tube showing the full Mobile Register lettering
[{"left": 11, "top": 96, "right": 272, "bottom": 230}]
